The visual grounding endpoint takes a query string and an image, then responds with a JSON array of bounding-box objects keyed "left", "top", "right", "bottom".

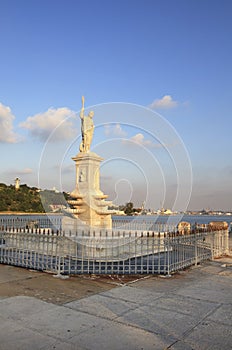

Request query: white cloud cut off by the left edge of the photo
[{"left": 0, "top": 103, "right": 20, "bottom": 143}]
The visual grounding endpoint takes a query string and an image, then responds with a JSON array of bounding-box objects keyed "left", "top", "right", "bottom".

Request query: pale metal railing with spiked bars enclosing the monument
[{"left": 0, "top": 227, "right": 228, "bottom": 275}]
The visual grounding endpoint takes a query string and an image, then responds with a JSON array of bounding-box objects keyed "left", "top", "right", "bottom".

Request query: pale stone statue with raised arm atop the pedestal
[{"left": 80, "top": 96, "right": 94, "bottom": 152}]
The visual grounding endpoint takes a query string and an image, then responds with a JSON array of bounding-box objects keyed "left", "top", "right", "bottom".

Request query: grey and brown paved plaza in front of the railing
[{"left": 0, "top": 253, "right": 232, "bottom": 350}]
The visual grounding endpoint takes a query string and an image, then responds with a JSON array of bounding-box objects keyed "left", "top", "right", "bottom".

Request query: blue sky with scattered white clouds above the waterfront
[{"left": 0, "top": 0, "right": 232, "bottom": 210}]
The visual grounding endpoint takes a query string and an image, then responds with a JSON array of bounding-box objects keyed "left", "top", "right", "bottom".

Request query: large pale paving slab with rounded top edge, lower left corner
[{"left": 0, "top": 297, "right": 98, "bottom": 340}]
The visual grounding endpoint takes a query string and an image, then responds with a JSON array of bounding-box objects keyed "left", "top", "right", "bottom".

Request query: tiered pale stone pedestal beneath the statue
[{"left": 65, "top": 152, "right": 113, "bottom": 229}]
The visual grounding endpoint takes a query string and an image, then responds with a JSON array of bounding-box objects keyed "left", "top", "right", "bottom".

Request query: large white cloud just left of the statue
[{"left": 20, "top": 107, "right": 76, "bottom": 141}]
